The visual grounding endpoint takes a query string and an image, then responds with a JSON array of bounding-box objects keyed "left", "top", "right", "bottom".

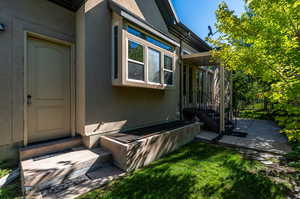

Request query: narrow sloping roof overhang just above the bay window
[{"left": 109, "top": 0, "right": 180, "bottom": 47}]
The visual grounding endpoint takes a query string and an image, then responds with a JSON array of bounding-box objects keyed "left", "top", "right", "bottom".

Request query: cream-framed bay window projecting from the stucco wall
[{"left": 113, "top": 21, "right": 177, "bottom": 89}]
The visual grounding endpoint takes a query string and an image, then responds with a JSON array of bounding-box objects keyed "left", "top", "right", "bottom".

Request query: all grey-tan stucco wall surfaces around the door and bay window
[{"left": 0, "top": 0, "right": 206, "bottom": 155}]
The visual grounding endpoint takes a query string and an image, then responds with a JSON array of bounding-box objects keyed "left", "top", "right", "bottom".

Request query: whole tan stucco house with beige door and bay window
[{"left": 0, "top": 0, "right": 225, "bottom": 165}]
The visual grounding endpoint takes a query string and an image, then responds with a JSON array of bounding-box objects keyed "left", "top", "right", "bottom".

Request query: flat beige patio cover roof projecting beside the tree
[{"left": 182, "top": 51, "right": 220, "bottom": 66}]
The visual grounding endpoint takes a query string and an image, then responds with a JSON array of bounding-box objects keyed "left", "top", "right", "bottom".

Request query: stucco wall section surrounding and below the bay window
[{"left": 85, "top": 0, "right": 179, "bottom": 134}]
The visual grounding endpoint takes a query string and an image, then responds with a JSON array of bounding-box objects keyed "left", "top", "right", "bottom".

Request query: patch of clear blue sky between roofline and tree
[{"left": 172, "top": 0, "right": 244, "bottom": 39}]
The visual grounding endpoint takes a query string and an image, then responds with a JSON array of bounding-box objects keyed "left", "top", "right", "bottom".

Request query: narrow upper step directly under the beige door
[{"left": 19, "top": 136, "right": 82, "bottom": 160}]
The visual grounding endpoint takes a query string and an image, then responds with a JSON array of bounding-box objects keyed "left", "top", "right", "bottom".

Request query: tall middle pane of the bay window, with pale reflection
[{"left": 148, "top": 48, "right": 160, "bottom": 83}]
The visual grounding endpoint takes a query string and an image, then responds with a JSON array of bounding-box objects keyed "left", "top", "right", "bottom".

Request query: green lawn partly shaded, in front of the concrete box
[{"left": 78, "top": 143, "right": 289, "bottom": 199}]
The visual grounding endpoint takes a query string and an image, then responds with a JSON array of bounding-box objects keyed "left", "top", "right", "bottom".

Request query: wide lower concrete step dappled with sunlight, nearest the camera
[{"left": 21, "top": 147, "right": 112, "bottom": 194}]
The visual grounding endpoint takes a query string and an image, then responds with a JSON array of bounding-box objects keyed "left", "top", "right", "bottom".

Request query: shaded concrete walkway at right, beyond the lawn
[{"left": 197, "top": 118, "right": 291, "bottom": 155}]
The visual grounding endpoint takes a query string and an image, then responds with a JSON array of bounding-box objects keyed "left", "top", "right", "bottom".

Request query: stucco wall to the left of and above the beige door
[{"left": 0, "top": 0, "right": 75, "bottom": 159}]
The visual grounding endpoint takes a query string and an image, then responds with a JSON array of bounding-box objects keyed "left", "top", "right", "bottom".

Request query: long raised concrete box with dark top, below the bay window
[{"left": 100, "top": 121, "right": 201, "bottom": 171}]
